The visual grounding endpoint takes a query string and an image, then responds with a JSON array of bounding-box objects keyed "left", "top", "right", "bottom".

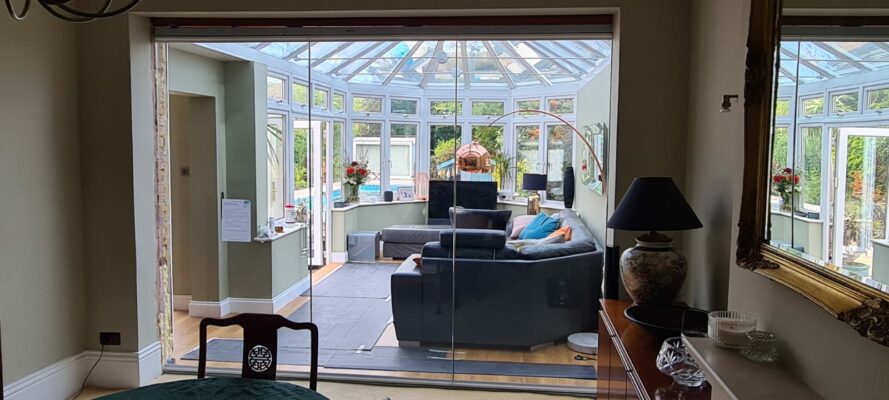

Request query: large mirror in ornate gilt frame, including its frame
[{"left": 736, "top": 0, "right": 889, "bottom": 346}]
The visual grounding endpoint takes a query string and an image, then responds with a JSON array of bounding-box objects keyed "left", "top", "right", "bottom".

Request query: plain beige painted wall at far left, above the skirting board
[{"left": 0, "top": 12, "right": 86, "bottom": 382}]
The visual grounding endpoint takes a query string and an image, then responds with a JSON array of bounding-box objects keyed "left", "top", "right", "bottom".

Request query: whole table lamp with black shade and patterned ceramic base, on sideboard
[{"left": 606, "top": 177, "right": 703, "bottom": 303}]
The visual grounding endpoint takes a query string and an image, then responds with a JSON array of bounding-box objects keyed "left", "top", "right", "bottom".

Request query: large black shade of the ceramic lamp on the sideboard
[{"left": 606, "top": 177, "right": 703, "bottom": 231}]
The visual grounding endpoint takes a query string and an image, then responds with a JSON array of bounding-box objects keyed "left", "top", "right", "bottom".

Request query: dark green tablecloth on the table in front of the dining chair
[{"left": 102, "top": 378, "right": 328, "bottom": 400}]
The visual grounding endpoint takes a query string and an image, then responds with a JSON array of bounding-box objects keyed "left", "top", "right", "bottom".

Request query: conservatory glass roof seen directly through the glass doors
[{"left": 236, "top": 40, "right": 611, "bottom": 88}]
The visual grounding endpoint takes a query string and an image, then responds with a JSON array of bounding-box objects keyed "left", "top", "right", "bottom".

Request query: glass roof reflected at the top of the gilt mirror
[{"left": 778, "top": 41, "right": 889, "bottom": 86}]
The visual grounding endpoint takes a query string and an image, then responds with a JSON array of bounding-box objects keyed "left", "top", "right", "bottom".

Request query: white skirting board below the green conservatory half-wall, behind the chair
[{"left": 188, "top": 276, "right": 309, "bottom": 318}]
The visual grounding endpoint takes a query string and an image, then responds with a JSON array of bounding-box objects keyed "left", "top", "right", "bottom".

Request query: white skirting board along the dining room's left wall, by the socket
[{"left": 3, "top": 342, "right": 163, "bottom": 400}]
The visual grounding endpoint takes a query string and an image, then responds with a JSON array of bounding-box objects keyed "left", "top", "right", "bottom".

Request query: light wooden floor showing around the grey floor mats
[{"left": 173, "top": 264, "right": 596, "bottom": 389}]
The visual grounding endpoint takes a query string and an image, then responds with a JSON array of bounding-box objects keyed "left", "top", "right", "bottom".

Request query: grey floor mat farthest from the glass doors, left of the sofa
[{"left": 303, "top": 263, "right": 398, "bottom": 299}]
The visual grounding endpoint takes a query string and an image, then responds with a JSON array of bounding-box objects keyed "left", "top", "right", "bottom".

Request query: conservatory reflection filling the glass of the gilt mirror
[{"left": 770, "top": 41, "right": 889, "bottom": 290}]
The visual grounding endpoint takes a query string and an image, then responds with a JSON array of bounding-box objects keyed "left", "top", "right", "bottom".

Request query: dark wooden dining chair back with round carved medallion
[{"left": 198, "top": 313, "right": 318, "bottom": 390}]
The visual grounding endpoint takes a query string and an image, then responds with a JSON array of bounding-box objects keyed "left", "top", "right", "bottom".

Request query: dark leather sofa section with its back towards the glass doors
[{"left": 391, "top": 210, "right": 603, "bottom": 349}]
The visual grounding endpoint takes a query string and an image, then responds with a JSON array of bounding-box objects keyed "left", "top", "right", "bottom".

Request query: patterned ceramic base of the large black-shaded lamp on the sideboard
[{"left": 620, "top": 232, "right": 687, "bottom": 303}]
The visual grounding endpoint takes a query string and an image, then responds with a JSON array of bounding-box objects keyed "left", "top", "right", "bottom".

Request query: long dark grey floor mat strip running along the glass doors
[{"left": 182, "top": 339, "right": 596, "bottom": 379}]
